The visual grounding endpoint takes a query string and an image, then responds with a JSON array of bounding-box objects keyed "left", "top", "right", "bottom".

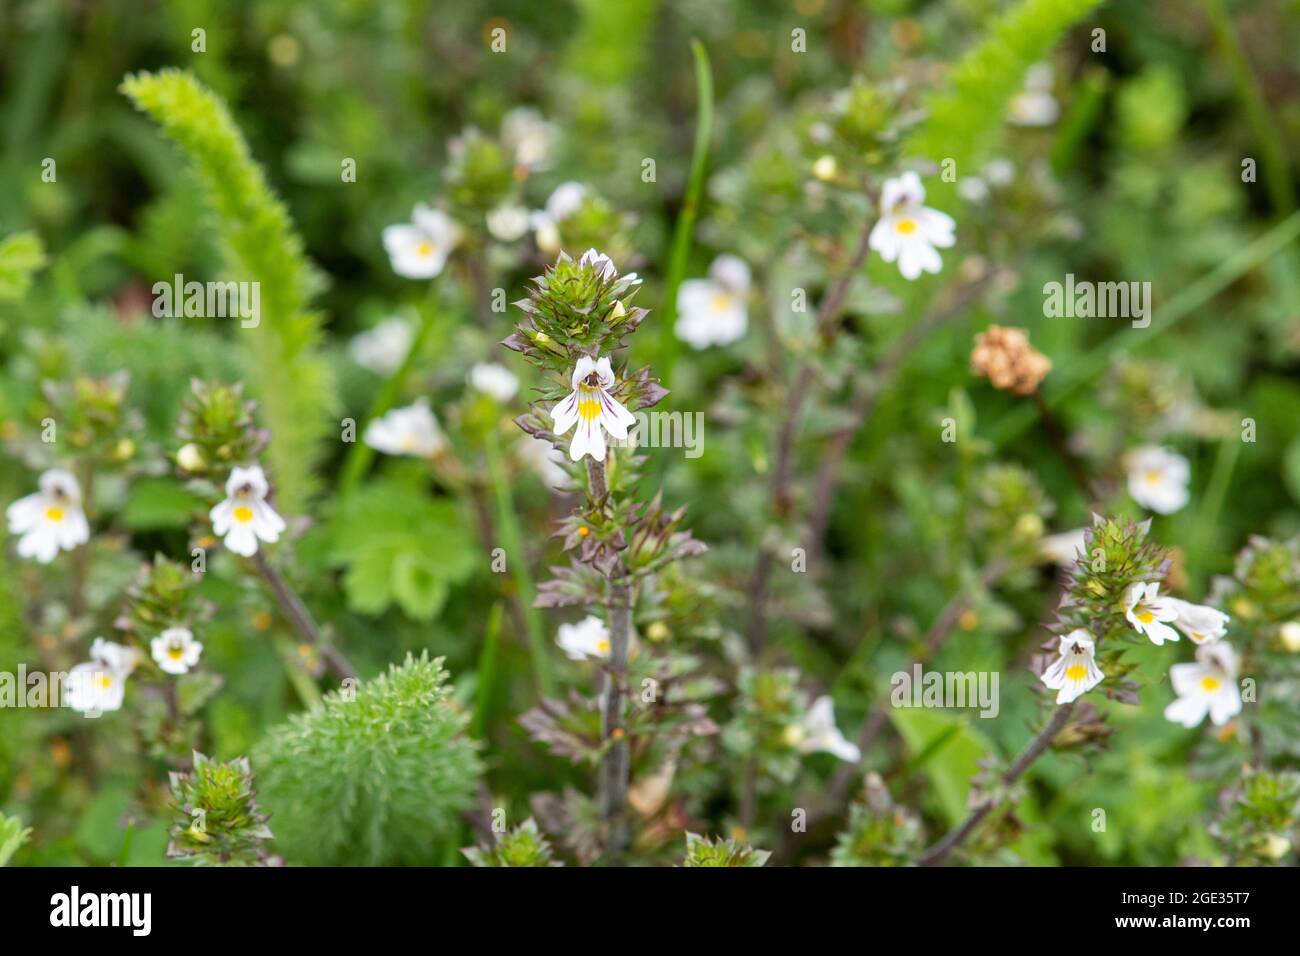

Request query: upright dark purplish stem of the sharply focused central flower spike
[{"left": 586, "top": 458, "right": 632, "bottom": 862}]
